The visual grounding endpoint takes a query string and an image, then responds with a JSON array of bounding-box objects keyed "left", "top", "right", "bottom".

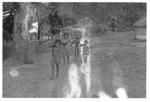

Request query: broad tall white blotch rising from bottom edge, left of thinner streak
[{"left": 66, "top": 64, "right": 81, "bottom": 98}]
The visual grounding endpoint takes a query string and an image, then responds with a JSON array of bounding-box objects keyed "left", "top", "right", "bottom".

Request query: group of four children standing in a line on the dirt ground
[{"left": 49, "top": 33, "right": 89, "bottom": 80}]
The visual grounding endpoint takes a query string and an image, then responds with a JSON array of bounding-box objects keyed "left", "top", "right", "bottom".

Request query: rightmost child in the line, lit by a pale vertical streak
[{"left": 80, "top": 40, "right": 89, "bottom": 63}]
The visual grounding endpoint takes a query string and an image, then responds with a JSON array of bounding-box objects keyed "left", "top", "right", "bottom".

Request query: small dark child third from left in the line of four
[{"left": 72, "top": 37, "right": 80, "bottom": 59}]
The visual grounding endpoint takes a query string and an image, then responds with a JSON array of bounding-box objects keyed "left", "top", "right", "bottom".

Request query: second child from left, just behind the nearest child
[{"left": 62, "top": 33, "right": 71, "bottom": 64}]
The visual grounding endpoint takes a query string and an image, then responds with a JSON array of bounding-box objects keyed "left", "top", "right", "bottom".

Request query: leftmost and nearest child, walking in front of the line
[{"left": 50, "top": 40, "right": 61, "bottom": 80}]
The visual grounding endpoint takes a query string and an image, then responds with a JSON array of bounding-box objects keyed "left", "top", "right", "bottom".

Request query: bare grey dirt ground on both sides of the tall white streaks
[{"left": 3, "top": 31, "right": 146, "bottom": 97}]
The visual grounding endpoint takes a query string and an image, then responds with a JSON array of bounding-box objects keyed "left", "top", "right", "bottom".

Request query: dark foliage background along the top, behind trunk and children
[{"left": 3, "top": 2, "right": 146, "bottom": 60}]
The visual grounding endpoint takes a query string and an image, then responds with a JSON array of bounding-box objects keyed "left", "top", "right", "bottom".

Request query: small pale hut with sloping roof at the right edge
[{"left": 134, "top": 15, "right": 146, "bottom": 40}]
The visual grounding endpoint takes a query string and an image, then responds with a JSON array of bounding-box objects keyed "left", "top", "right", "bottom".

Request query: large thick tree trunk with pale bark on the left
[{"left": 14, "top": 3, "right": 37, "bottom": 63}]
